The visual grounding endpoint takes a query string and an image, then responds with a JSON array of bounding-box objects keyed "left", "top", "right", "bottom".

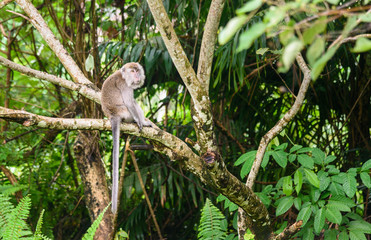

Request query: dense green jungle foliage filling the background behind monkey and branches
[{"left": 0, "top": 0, "right": 371, "bottom": 239}]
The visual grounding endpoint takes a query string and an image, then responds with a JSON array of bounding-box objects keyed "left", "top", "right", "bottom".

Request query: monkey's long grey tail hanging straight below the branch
[{"left": 111, "top": 118, "right": 121, "bottom": 214}]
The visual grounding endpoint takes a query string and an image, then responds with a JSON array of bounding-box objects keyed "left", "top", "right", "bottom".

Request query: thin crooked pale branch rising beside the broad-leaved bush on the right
[{"left": 246, "top": 53, "right": 311, "bottom": 187}]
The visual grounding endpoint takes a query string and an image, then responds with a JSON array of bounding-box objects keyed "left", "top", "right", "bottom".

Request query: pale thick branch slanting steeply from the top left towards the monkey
[{"left": 16, "top": 0, "right": 93, "bottom": 86}]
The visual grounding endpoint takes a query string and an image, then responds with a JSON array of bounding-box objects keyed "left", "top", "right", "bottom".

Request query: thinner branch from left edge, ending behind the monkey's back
[{"left": 0, "top": 56, "right": 100, "bottom": 103}]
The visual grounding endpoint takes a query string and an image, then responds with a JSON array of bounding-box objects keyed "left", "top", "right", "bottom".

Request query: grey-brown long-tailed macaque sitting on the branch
[{"left": 101, "top": 62, "right": 152, "bottom": 214}]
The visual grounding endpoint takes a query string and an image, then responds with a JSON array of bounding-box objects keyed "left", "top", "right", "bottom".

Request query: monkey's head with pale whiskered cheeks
[{"left": 121, "top": 62, "right": 145, "bottom": 89}]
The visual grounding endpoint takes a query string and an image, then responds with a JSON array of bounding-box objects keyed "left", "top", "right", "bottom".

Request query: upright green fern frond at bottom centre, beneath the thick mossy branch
[{"left": 197, "top": 198, "right": 227, "bottom": 240}]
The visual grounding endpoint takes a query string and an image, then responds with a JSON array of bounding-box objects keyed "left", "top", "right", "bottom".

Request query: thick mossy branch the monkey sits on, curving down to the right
[{"left": 0, "top": 107, "right": 271, "bottom": 239}]
